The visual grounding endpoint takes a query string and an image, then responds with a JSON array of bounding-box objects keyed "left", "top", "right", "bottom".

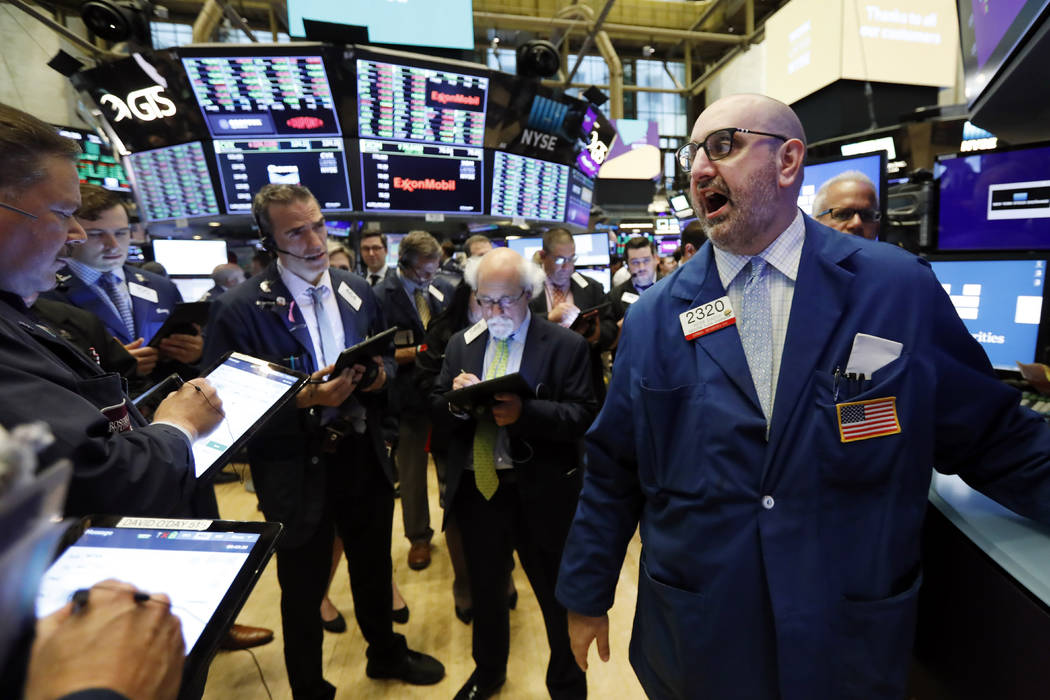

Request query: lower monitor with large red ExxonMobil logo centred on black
[{"left": 360, "top": 139, "right": 484, "bottom": 214}]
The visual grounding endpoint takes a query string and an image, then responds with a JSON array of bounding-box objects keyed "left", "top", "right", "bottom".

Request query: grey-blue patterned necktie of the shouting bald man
[{"left": 738, "top": 255, "right": 773, "bottom": 423}]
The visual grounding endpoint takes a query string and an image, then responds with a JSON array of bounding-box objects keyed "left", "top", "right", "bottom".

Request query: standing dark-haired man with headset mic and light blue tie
[{"left": 204, "top": 185, "right": 444, "bottom": 700}]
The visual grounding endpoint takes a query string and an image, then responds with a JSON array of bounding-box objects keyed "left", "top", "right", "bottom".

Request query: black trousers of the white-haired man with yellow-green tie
[{"left": 453, "top": 471, "right": 587, "bottom": 700}]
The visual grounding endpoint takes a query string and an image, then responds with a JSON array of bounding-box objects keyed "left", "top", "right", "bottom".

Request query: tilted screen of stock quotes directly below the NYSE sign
[{"left": 489, "top": 151, "right": 567, "bottom": 221}]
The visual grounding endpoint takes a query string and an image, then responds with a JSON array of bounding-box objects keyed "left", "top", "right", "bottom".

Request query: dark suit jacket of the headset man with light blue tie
[{"left": 203, "top": 264, "right": 396, "bottom": 547}]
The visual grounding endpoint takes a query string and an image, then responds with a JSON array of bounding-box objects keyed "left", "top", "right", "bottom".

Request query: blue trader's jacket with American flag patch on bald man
[{"left": 558, "top": 217, "right": 1050, "bottom": 700}]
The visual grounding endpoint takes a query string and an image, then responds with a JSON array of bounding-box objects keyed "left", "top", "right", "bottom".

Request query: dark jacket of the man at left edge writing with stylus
[{"left": 0, "top": 294, "right": 200, "bottom": 517}]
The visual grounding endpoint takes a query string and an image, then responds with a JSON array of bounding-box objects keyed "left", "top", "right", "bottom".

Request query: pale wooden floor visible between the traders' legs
[{"left": 204, "top": 463, "right": 645, "bottom": 700}]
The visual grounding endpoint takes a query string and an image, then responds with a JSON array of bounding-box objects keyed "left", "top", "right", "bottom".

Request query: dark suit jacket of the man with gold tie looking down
[{"left": 372, "top": 271, "right": 456, "bottom": 415}]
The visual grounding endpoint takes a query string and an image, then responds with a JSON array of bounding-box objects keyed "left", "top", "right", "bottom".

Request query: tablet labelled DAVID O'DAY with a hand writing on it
[{"left": 36, "top": 515, "right": 282, "bottom": 682}]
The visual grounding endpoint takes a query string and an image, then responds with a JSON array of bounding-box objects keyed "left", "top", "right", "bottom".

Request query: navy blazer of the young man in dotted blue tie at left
[{"left": 45, "top": 264, "right": 183, "bottom": 345}]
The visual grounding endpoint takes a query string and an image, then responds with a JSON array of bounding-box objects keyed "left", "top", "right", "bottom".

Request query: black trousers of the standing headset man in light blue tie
[{"left": 276, "top": 434, "right": 405, "bottom": 700}]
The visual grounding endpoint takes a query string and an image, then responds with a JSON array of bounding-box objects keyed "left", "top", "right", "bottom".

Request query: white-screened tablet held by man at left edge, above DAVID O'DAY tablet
[{"left": 193, "top": 353, "right": 308, "bottom": 479}]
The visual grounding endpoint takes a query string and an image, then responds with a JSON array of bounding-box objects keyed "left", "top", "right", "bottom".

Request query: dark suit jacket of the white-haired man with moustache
[{"left": 431, "top": 315, "right": 597, "bottom": 546}]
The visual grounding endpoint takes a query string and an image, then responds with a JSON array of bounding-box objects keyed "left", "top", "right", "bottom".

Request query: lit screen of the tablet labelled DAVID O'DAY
[{"left": 37, "top": 527, "right": 259, "bottom": 655}]
